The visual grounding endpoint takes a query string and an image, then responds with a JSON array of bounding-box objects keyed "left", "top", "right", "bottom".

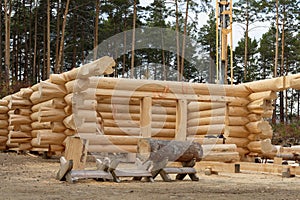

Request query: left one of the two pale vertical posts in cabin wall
[{"left": 140, "top": 97, "right": 152, "bottom": 138}]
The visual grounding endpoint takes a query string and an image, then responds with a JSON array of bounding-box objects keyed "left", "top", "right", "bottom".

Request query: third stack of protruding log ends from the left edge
[{"left": 30, "top": 80, "right": 66, "bottom": 152}]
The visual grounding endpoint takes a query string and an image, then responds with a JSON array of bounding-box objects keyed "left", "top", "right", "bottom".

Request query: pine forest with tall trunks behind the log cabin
[{"left": 0, "top": 0, "right": 300, "bottom": 144}]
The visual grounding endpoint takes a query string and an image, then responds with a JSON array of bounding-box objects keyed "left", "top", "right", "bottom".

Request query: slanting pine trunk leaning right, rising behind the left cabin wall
[{"left": 55, "top": 0, "right": 70, "bottom": 73}]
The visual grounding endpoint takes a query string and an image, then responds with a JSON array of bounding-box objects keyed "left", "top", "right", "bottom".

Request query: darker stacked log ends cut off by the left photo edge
[{"left": 0, "top": 100, "right": 8, "bottom": 150}]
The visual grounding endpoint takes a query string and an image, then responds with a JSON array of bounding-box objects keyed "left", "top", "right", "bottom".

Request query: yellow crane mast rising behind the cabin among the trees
[{"left": 216, "top": 0, "right": 233, "bottom": 84}]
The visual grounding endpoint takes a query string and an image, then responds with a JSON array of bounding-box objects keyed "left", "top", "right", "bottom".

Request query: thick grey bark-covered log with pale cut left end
[{"left": 137, "top": 138, "right": 203, "bottom": 162}]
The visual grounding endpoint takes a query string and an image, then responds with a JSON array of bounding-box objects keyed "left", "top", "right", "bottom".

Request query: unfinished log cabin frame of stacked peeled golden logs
[{"left": 0, "top": 57, "right": 300, "bottom": 160}]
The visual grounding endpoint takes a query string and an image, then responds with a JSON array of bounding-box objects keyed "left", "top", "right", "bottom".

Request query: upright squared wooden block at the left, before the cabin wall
[{"left": 65, "top": 137, "right": 88, "bottom": 170}]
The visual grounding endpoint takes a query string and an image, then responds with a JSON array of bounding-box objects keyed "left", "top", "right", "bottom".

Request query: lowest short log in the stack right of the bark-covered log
[{"left": 202, "top": 152, "right": 240, "bottom": 163}]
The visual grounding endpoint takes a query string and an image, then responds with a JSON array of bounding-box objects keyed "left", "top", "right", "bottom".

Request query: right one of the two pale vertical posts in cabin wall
[{"left": 175, "top": 99, "right": 187, "bottom": 141}]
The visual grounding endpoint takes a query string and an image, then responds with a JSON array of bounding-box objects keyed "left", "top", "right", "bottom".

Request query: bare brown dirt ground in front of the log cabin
[{"left": 0, "top": 153, "right": 300, "bottom": 200}]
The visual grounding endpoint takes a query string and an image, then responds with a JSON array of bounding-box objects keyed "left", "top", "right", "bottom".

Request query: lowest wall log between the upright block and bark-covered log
[{"left": 88, "top": 145, "right": 137, "bottom": 153}]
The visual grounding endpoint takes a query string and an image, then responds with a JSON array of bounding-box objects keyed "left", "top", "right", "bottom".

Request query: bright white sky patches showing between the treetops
[{"left": 140, "top": 0, "right": 269, "bottom": 47}]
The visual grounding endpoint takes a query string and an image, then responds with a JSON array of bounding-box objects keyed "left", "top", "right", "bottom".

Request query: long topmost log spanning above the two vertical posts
[{"left": 98, "top": 78, "right": 249, "bottom": 97}]
